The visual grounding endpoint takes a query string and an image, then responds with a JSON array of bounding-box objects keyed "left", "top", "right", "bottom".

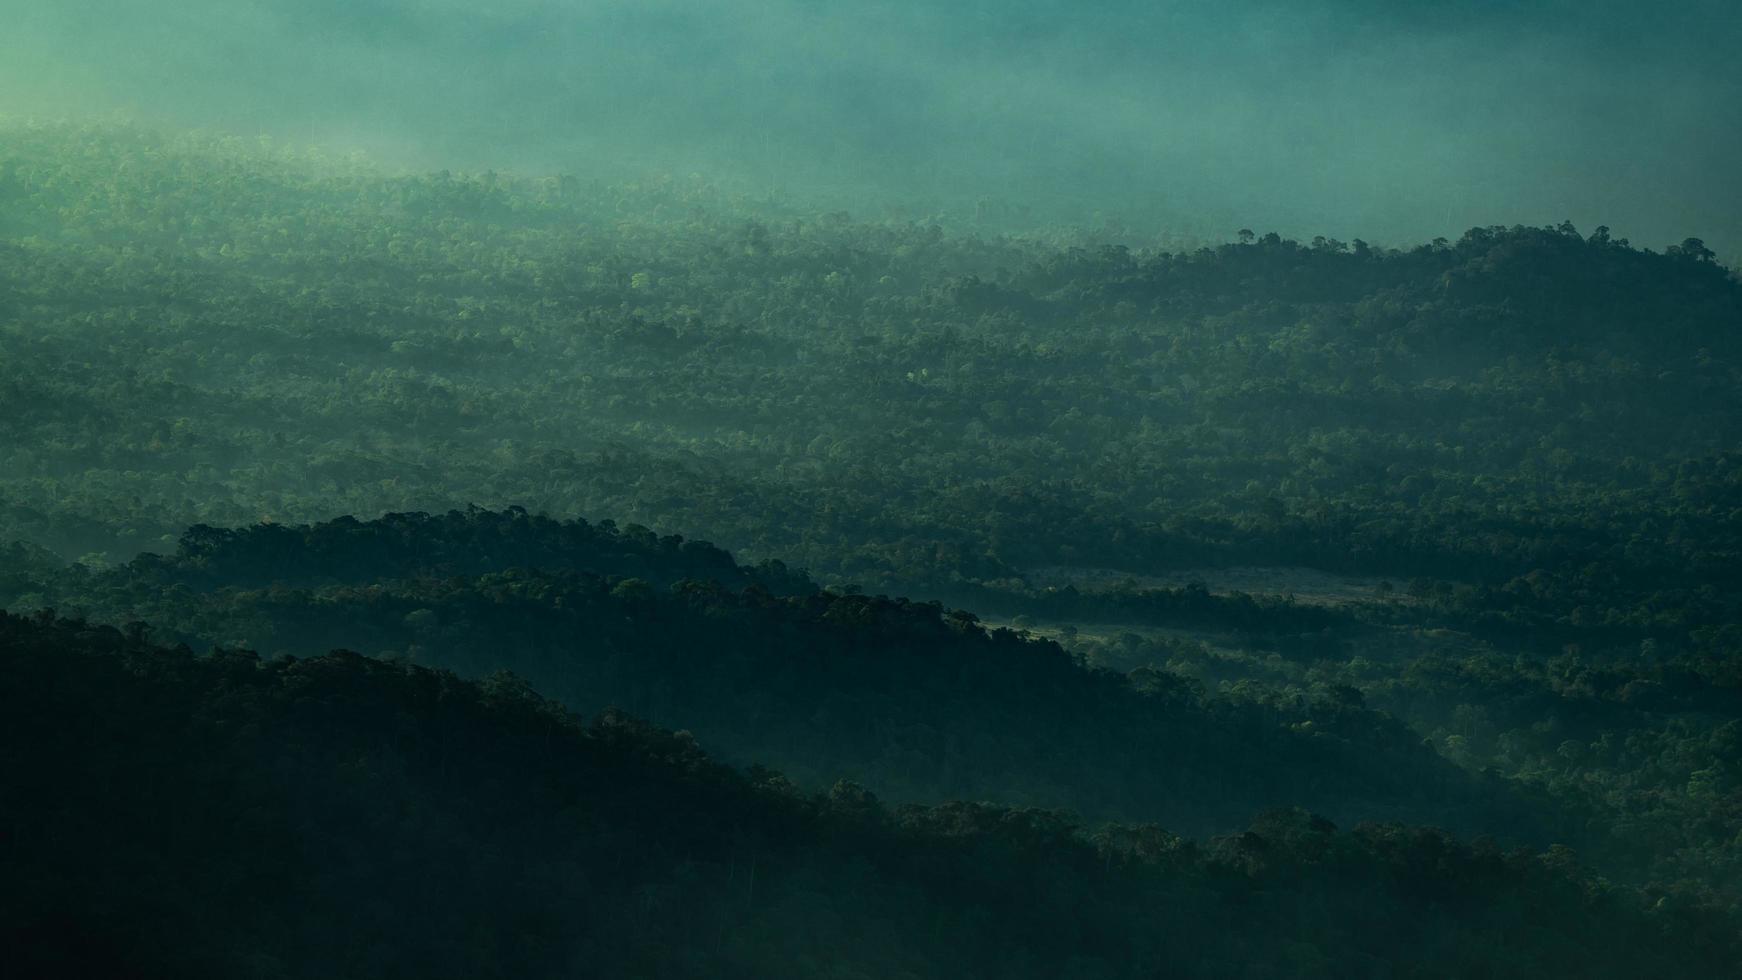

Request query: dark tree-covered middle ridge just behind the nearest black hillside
[{"left": 13, "top": 510, "right": 1539, "bottom": 846}]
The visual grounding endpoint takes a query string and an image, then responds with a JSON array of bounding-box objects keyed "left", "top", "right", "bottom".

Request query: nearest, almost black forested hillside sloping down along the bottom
[{"left": 0, "top": 614, "right": 1742, "bottom": 980}]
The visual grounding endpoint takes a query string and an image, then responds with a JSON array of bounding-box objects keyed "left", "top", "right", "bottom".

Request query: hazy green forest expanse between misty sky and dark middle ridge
[{"left": 0, "top": 120, "right": 1742, "bottom": 630}]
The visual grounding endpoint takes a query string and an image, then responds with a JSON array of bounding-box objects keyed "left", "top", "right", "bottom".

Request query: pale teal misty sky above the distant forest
[{"left": 0, "top": 0, "right": 1742, "bottom": 252}]
